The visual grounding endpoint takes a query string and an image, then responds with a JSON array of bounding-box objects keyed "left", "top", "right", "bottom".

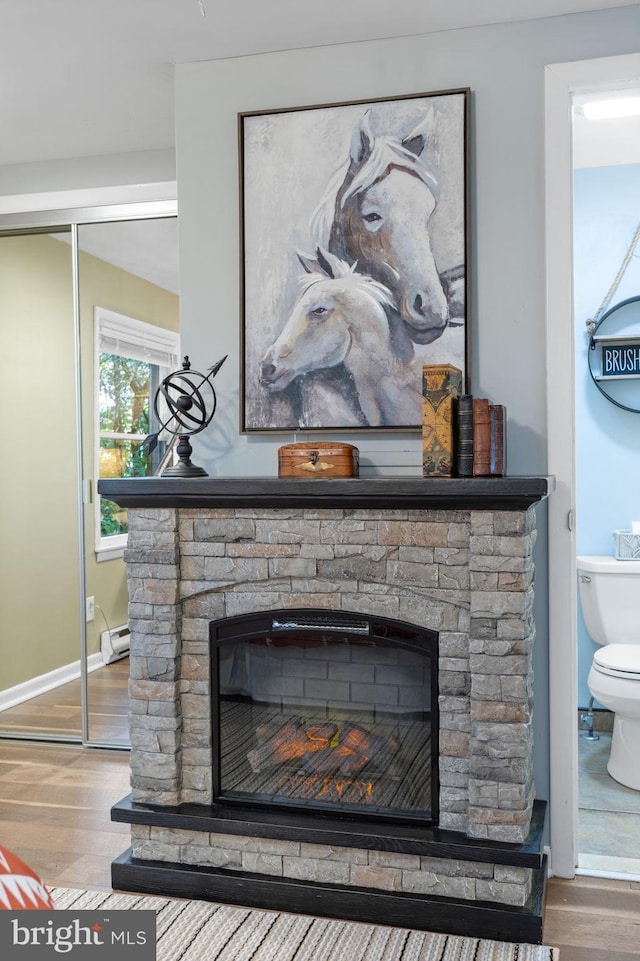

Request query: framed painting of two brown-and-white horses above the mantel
[{"left": 239, "top": 89, "right": 469, "bottom": 433}]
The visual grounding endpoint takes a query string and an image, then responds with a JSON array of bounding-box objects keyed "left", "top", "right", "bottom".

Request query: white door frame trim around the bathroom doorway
[{"left": 545, "top": 54, "right": 640, "bottom": 877}]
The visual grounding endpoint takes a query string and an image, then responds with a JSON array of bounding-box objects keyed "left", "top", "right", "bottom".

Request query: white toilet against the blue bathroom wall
[{"left": 577, "top": 556, "right": 640, "bottom": 791}]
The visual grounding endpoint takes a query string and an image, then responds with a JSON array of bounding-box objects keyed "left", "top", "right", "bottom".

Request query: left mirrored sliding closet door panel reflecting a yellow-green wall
[{"left": 0, "top": 231, "right": 82, "bottom": 740}]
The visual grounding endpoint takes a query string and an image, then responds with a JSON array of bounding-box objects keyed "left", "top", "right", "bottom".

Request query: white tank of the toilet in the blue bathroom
[{"left": 577, "top": 555, "right": 640, "bottom": 644}]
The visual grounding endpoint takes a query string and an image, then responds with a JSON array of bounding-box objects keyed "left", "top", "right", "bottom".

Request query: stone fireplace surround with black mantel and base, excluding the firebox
[{"left": 100, "top": 478, "right": 548, "bottom": 940}]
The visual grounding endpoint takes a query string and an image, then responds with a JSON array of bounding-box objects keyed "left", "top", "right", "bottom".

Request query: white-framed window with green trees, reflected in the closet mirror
[{"left": 95, "top": 307, "right": 180, "bottom": 560}]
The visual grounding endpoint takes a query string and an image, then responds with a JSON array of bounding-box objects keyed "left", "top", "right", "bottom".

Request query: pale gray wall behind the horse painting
[{"left": 176, "top": 5, "right": 640, "bottom": 797}]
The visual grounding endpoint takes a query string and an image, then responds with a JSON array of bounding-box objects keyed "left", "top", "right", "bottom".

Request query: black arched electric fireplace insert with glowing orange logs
[{"left": 211, "top": 610, "right": 438, "bottom": 823}]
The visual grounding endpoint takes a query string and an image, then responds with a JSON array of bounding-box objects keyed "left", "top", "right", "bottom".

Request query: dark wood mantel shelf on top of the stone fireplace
[{"left": 98, "top": 476, "right": 555, "bottom": 511}]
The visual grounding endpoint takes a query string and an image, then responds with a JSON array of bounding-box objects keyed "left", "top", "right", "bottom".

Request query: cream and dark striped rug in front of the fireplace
[{"left": 50, "top": 888, "right": 560, "bottom": 961}]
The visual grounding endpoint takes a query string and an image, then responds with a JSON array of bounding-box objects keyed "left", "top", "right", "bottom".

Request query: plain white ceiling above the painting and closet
[{"left": 0, "top": 0, "right": 635, "bottom": 168}]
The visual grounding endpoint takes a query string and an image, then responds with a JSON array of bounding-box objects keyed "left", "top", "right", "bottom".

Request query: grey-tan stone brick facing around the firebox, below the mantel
[{"left": 125, "top": 507, "right": 536, "bottom": 848}]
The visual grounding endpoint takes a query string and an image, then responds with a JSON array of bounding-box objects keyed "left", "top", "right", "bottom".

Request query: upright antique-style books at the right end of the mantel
[{"left": 422, "top": 364, "right": 506, "bottom": 477}]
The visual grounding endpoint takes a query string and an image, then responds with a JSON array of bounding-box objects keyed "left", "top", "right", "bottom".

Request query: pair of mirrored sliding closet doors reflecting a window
[{"left": 0, "top": 201, "right": 179, "bottom": 748}]
